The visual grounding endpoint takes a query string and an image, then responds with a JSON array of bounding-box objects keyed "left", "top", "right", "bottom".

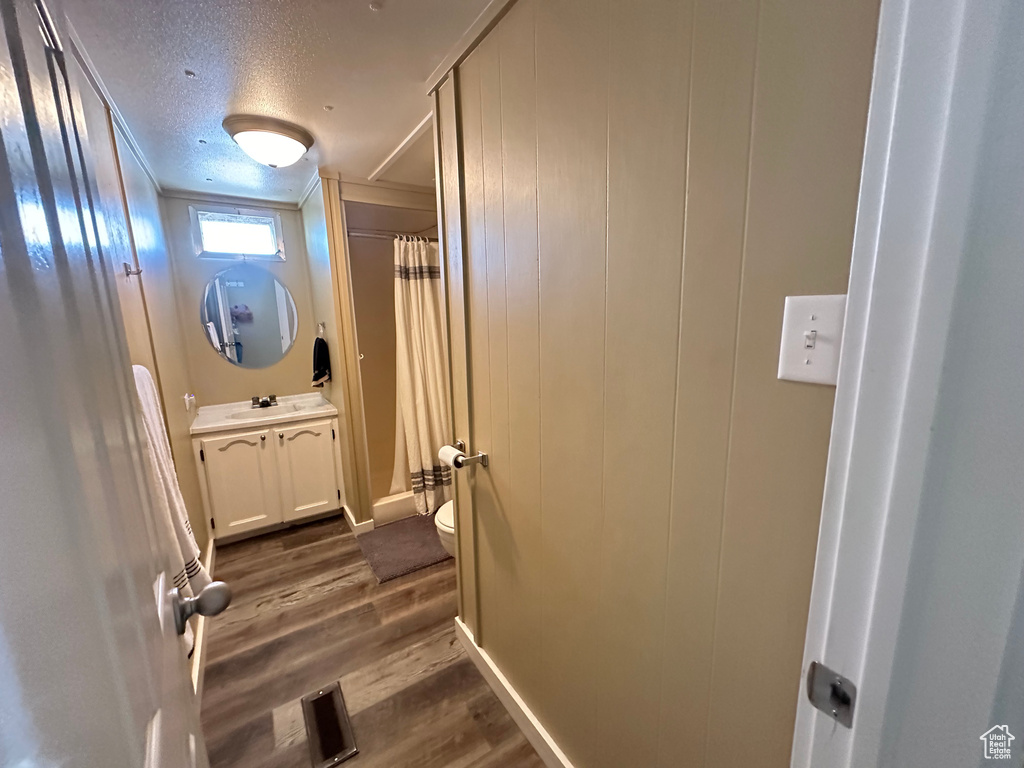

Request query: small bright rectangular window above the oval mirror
[{"left": 188, "top": 206, "right": 285, "bottom": 261}]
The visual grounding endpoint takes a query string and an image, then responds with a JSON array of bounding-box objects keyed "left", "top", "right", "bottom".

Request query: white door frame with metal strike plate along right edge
[{"left": 793, "top": 0, "right": 1024, "bottom": 768}]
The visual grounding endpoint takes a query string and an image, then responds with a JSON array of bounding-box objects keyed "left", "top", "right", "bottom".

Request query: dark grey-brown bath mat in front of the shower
[{"left": 355, "top": 515, "right": 452, "bottom": 584}]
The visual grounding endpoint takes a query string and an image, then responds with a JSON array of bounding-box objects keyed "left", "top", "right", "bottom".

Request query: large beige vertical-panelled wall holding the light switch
[{"left": 440, "top": 0, "right": 878, "bottom": 768}]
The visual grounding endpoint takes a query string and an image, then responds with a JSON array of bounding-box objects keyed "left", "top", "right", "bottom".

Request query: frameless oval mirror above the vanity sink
[{"left": 200, "top": 264, "right": 299, "bottom": 368}]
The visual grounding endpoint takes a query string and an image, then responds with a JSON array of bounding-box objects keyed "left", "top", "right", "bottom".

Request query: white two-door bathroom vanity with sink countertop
[{"left": 190, "top": 392, "right": 345, "bottom": 539}]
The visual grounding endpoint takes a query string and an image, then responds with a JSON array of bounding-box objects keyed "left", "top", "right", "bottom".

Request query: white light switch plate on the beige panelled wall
[{"left": 778, "top": 294, "right": 846, "bottom": 386}]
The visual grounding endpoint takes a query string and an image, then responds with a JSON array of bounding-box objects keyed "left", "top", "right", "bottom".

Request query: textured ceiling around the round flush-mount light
[{"left": 65, "top": 0, "right": 486, "bottom": 202}]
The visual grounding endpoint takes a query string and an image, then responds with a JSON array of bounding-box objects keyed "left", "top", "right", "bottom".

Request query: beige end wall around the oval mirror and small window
[{"left": 161, "top": 197, "right": 321, "bottom": 406}]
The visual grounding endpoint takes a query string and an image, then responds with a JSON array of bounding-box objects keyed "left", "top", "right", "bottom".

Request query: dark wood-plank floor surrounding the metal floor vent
[{"left": 194, "top": 517, "right": 543, "bottom": 768}]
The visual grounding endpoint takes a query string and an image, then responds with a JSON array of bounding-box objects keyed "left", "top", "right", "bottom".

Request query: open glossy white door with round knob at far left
[{"left": 0, "top": 0, "right": 207, "bottom": 768}]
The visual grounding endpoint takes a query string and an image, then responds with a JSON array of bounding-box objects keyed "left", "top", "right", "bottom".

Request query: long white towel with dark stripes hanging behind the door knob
[{"left": 132, "top": 366, "right": 210, "bottom": 656}]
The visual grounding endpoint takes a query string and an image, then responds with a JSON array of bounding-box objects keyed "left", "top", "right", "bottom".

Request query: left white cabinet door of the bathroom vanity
[{"left": 203, "top": 429, "right": 282, "bottom": 537}]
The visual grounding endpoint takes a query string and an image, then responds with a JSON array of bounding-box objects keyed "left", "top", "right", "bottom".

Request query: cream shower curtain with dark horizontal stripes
[{"left": 391, "top": 237, "right": 452, "bottom": 515}]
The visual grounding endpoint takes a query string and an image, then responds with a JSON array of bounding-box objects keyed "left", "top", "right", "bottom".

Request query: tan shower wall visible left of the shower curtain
[{"left": 348, "top": 238, "right": 396, "bottom": 500}]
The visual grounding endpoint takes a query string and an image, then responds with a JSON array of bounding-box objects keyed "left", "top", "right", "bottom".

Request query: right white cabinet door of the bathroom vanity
[{"left": 273, "top": 420, "right": 341, "bottom": 520}]
